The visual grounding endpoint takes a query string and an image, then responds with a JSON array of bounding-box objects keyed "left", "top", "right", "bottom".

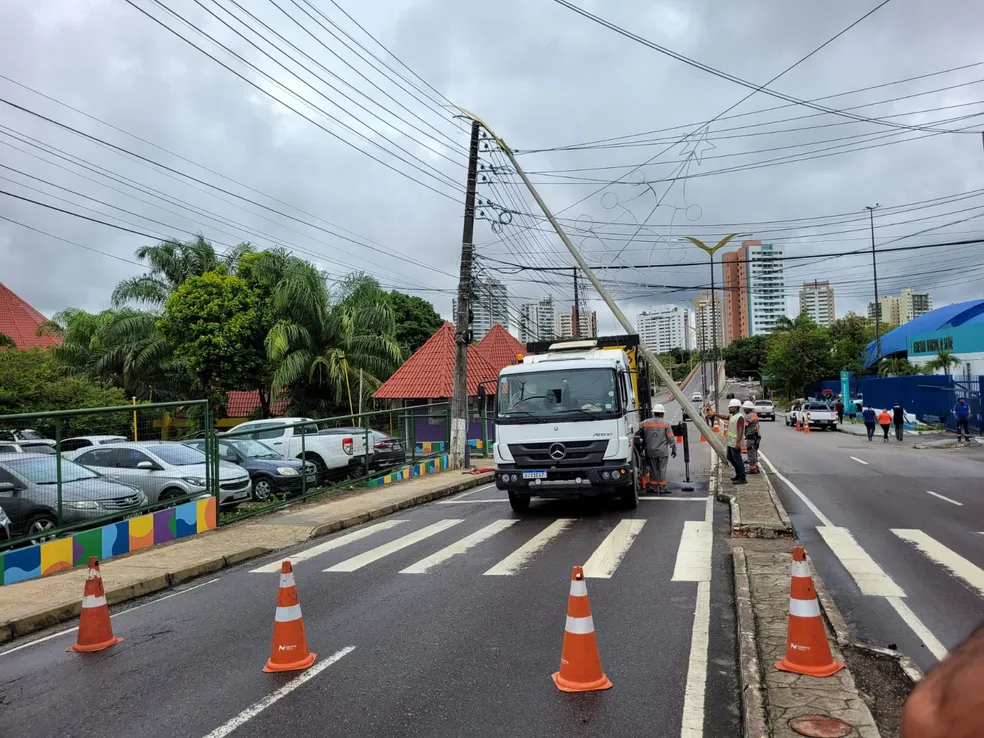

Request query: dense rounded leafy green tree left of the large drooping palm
[{"left": 157, "top": 272, "right": 266, "bottom": 405}]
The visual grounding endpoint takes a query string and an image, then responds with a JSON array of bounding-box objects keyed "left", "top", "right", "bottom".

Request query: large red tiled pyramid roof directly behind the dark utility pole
[{"left": 373, "top": 322, "right": 499, "bottom": 400}]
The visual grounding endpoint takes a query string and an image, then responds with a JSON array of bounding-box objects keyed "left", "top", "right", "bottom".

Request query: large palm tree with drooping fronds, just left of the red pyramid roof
[{"left": 264, "top": 262, "right": 402, "bottom": 413}]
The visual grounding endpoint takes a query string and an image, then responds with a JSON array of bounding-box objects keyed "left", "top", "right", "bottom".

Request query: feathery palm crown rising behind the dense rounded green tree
[{"left": 113, "top": 236, "right": 254, "bottom": 307}]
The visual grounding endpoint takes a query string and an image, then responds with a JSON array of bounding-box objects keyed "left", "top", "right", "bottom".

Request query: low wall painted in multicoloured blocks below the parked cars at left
[{"left": 0, "top": 497, "right": 216, "bottom": 584}]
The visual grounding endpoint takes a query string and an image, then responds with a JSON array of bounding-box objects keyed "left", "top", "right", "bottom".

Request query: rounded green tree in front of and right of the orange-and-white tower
[{"left": 763, "top": 315, "right": 838, "bottom": 398}]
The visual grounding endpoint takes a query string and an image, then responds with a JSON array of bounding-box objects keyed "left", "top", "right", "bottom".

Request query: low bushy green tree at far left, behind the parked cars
[{"left": 0, "top": 349, "right": 128, "bottom": 434}]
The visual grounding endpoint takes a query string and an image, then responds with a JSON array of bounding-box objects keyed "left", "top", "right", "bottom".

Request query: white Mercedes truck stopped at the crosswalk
[{"left": 493, "top": 336, "right": 651, "bottom": 512}]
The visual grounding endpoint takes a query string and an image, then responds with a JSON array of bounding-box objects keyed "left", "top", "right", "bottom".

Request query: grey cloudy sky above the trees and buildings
[{"left": 0, "top": 0, "right": 984, "bottom": 329}]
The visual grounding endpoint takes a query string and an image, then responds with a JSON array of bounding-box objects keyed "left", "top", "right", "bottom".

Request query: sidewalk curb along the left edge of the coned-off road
[{"left": 0, "top": 473, "right": 495, "bottom": 644}]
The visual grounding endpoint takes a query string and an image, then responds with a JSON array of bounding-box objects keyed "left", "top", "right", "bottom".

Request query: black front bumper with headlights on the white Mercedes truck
[{"left": 495, "top": 462, "right": 634, "bottom": 498}]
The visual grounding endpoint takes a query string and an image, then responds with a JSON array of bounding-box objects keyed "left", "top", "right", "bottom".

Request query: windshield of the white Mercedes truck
[{"left": 497, "top": 369, "right": 620, "bottom": 423}]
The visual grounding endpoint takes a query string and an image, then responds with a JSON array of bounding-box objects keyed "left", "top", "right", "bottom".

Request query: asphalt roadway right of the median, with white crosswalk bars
[{"left": 761, "top": 416, "right": 984, "bottom": 669}]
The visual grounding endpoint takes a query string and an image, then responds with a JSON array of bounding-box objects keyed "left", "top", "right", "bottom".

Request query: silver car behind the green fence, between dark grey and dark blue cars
[{"left": 64, "top": 441, "right": 252, "bottom": 506}]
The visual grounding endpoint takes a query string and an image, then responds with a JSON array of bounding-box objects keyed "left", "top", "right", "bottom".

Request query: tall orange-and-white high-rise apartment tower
[{"left": 722, "top": 241, "right": 786, "bottom": 343}]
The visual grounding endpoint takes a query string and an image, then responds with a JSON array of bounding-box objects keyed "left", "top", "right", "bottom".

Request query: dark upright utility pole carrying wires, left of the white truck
[{"left": 450, "top": 120, "right": 480, "bottom": 469}]
